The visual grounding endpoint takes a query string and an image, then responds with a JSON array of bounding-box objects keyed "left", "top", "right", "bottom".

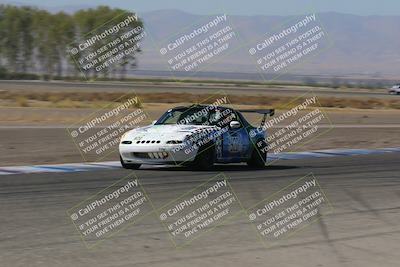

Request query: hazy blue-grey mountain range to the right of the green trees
[{"left": 139, "top": 10, "right": 400, "bottom": 78}]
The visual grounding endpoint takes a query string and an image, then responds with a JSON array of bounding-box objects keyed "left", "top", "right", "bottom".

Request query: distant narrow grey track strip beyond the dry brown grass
[{"left": 0, "top": 81, "right": 399, "bottom": 99}]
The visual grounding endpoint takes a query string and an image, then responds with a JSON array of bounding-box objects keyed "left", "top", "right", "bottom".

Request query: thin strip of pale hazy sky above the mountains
[{"left": 0, "top": 0, "right": 400, "bottom": 15}]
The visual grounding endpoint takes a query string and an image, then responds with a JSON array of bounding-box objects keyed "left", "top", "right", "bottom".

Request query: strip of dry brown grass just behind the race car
[{"left": 0, "top": 91, "right": 400, "bottom": 109}]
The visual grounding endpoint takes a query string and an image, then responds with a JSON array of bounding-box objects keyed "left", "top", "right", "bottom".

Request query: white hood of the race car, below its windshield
[{"left": 123, "top": 124, "right": 218, "bottom": 141}]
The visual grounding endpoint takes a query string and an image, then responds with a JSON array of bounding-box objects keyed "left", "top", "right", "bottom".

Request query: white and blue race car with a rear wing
[{"left": 119, "top": 105, "right": 274, "bottom": 169}]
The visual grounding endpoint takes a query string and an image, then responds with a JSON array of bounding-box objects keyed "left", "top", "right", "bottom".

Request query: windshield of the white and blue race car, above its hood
[{"left": 155, "top": 106, "right": 236, "bottom": 126}]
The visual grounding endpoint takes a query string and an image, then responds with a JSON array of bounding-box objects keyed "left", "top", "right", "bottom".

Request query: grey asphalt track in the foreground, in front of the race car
[{"left": 0, "top": 153, "right": 400, "bottom": 267}]
